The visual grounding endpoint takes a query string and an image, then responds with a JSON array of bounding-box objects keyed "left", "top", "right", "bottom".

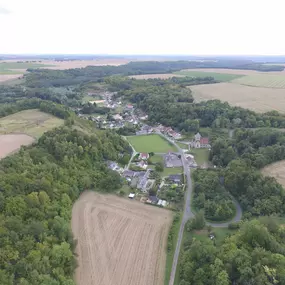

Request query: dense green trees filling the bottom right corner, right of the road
[{"left": 178, "top": 217, "right": 285, "bottom": 285}]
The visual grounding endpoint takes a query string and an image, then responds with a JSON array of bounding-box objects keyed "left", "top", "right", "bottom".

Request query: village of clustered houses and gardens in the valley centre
[{"left": 75, "top": 87, "right": 211, "bottom": 208}]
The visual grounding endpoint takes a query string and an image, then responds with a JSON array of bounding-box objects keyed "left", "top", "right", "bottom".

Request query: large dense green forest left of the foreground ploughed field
[{"left": 0, "top": 123, "right": 130, "bottom": 285}]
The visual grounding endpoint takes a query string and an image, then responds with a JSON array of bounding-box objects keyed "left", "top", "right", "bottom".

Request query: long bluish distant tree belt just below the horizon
[{"left": 25, "top": 60, "right": 284, "bottom": 87}]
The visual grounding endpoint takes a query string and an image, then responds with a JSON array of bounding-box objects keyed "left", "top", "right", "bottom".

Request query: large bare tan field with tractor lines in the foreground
[{"left": 72, "top": 191, "right": 172, "bottom": 285}]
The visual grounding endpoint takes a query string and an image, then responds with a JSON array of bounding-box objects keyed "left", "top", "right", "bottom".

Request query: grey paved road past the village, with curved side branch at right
[{"left": 158, "top": 133, "right": 242, "bottom": 285}]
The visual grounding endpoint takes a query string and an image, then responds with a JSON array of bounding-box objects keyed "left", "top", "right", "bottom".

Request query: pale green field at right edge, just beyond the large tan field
[{"left": 232, "top": 72, "right": 285, "bottom": 88}]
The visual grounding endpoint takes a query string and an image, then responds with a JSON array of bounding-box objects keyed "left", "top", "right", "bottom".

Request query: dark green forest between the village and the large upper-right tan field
[{"left": 105, "top": 76, "right": 285, "bottom": 129}]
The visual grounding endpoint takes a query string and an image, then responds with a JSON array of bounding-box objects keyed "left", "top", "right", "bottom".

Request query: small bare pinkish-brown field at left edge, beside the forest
[{"left": 0, "top": 134, "right": 34, "bottom": 159}]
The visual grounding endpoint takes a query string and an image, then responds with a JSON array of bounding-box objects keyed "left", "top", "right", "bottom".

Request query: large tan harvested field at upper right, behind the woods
[{"left": 189, "top": 83, "right": 285, "bottom": 113}]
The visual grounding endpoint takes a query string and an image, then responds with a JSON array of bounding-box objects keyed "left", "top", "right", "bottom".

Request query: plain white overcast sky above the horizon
[{"left": 0, "top": 0, "right": 285, "bottom": 55}]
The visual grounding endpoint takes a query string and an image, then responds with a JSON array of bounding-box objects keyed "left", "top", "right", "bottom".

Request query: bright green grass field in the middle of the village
[{"left": 127, "top": 135, "right": 177, "bottom": 153}]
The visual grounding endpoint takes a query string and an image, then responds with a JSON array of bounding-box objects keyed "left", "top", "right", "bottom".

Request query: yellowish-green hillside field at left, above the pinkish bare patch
[{"left": 0, "top": 110, "right": 63, "bottom": 138}]
